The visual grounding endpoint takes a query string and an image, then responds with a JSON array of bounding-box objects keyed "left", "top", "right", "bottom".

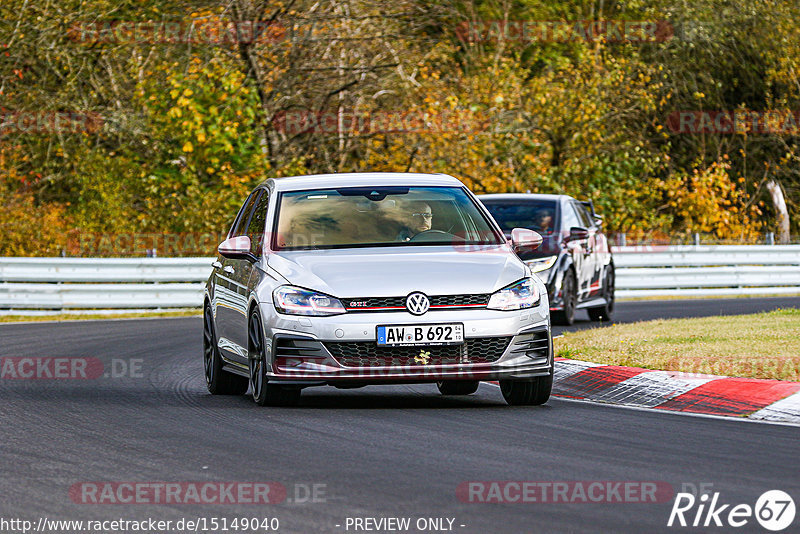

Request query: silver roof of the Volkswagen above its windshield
[{"left": 263, "top": 172, "right": 464, "bottom": 191}]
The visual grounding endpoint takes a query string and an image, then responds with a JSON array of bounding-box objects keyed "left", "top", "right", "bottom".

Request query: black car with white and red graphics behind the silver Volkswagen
[{"left": 478, "top": 194, "right": 614, "bottom": 325}]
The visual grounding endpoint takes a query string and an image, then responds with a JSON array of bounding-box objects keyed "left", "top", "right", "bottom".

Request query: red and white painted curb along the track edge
[{"left": 553, "top": 358, "right": 800, "bottom": 424}]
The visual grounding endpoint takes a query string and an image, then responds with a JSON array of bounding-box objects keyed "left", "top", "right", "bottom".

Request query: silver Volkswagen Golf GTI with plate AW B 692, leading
[{"left": 203, "top": 173, "right": 553, "bottom": 405}]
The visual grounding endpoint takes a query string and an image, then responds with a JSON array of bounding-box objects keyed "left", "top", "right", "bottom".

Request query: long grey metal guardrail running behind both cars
[{"left": 0, "top": 245, "right": 800, "bottom": 315}]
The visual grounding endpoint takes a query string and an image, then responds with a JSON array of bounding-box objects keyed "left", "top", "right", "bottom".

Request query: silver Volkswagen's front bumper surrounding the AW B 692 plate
[{"left": 265, "top": 303, "right": 553, "bottom": 386}]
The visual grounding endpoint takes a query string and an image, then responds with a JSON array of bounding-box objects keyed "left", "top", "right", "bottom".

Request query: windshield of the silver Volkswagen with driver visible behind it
[{"left": 272, "top": 186, "right": 505, "bottom": 250}]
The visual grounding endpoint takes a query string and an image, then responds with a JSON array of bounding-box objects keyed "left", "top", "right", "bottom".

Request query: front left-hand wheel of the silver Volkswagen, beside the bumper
[{"left": 247, "top": 309, "right": 300, "bottom": 406}]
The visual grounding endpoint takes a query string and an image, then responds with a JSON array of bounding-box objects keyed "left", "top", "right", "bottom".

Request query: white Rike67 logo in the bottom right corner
[{"left": 667, "top": 490, "right": 795, "bottom": 532}]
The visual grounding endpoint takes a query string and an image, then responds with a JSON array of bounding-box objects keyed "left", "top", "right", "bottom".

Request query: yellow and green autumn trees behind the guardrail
[{"left": 0, "top": 0, "right": 800, "bottom": 256}]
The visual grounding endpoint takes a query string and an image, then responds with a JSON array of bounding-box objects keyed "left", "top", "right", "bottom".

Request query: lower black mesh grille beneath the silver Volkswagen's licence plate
[{"left": 325, "top": 337, "right": 511, "bottom": 367}]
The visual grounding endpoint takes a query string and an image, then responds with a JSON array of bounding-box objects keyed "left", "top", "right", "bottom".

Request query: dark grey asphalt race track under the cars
[{"left": 0, "top": 299, "right": 800, "bottom": 533}]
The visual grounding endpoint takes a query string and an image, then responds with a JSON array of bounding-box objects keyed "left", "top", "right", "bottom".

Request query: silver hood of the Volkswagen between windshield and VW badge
[{"left": 268, "top": 245, "right": 526, "bottom": 298}]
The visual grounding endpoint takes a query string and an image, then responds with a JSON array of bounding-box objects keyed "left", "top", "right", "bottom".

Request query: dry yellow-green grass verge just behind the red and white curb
[{"left": 554, "top": 309, "right": 800, "bottom": 381}]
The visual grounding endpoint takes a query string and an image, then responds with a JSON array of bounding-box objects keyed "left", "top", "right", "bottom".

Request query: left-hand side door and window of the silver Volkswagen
[{"left": 215, "top": 189, "right": 262, "bottom": 363}]
